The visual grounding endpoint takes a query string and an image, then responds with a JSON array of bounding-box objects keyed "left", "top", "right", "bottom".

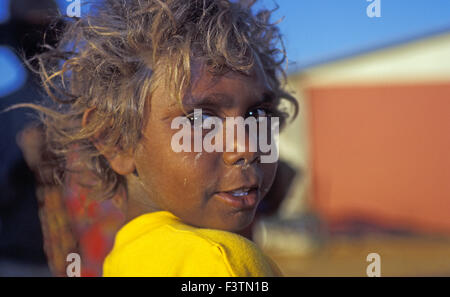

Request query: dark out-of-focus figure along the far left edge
[{"left": 0, "top": 0, "right": 61, "bottom": 276}]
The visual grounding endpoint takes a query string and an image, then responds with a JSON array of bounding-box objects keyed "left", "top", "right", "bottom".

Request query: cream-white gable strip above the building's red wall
[{"left": 291, "top": 33, "right": 450, "bottom": 87}]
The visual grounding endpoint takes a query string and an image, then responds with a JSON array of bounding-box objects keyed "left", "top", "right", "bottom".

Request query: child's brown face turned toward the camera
[{"left": 134, "top": 58, "right": 277, "bottom": 231}]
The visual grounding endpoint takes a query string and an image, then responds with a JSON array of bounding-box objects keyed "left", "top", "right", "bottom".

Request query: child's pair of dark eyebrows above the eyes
[{"left": 184, "top": 90, "right": 276, "bottom": 108}]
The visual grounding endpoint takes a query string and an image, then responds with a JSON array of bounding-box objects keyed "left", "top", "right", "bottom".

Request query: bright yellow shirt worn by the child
[{"left": 103, "top": 211, "right": 281, "bottom": 277}]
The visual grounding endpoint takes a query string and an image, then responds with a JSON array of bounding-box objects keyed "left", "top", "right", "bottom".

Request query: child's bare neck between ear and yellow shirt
[{"left": 126, "top": 174, "right": 161, "bottom": 222}]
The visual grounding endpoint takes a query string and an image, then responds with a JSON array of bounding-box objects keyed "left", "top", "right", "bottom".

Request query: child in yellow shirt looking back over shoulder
[{"left": 17, "top": 0, "right": 297, "bottom": 276}]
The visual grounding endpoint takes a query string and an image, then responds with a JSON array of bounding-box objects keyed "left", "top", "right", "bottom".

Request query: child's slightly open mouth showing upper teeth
[{"left": 215, "top": 187, "right": 259, "bottom": 210}]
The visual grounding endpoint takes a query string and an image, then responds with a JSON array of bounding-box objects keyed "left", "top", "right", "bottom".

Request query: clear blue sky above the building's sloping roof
[{"left": 0, "top": 0, "right": 450, "bottom": 94}]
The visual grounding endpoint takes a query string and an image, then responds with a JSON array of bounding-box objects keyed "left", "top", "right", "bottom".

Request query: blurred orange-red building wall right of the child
[{"left": 307, "top": 83, "right": 450, "bottom": 233}]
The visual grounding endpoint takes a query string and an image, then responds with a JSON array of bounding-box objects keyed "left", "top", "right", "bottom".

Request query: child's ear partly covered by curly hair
[{"left": 81, "top": 107, "right": 136, "bottom": 175}]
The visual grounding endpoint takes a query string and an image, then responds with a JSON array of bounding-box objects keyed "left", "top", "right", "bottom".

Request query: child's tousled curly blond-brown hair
[{"left": 12, "top": 0, "right": 298, "bottom": 198}]
